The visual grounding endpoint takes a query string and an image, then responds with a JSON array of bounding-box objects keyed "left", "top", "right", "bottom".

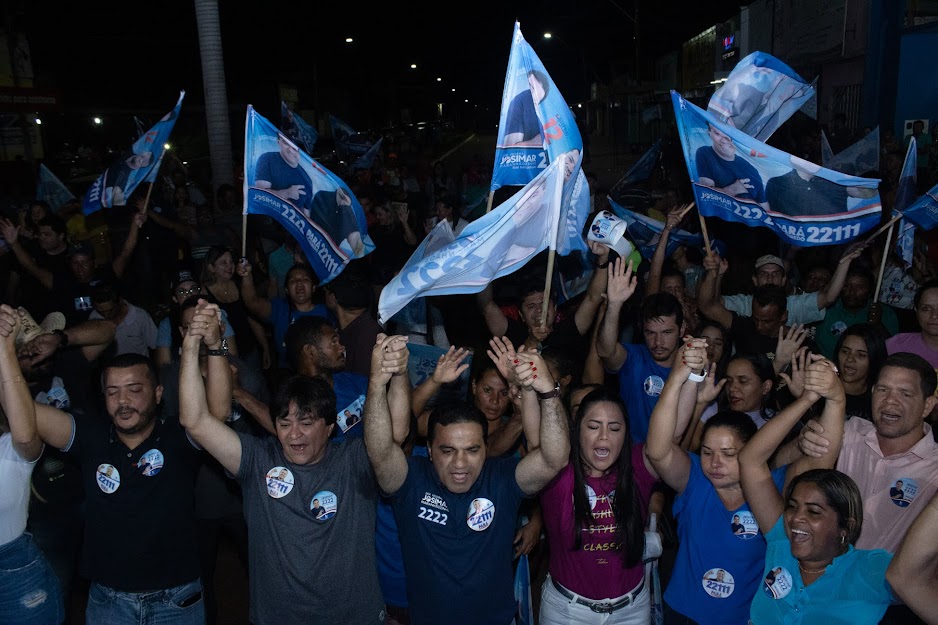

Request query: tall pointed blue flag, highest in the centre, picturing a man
[{"left": 491, "top": 22, "right": 583, "bottom": 191}]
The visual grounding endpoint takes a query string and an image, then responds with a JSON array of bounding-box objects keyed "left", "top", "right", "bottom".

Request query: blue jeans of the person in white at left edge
[{"left": 0, "top": 533, "right": 65, "bottom": 625}]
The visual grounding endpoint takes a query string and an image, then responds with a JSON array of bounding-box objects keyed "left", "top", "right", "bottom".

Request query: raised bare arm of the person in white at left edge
[{"left": 0, "top": 304, "right": 42, "bottom": 462}]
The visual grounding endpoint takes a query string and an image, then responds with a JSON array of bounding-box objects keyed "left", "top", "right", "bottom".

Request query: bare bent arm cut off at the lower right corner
[{"left": 886, "top": 495, "right": 938, "bottom": 625}]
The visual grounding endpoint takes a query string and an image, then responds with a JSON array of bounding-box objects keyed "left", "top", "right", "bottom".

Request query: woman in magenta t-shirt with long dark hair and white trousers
[{"left": 540, "top": 388, "right": 656, "bottom": 625}]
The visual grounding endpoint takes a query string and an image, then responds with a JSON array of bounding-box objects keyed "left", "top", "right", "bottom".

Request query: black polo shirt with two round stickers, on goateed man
[{"left": 67, "top": 417, "right": 199, "bottom": 592}]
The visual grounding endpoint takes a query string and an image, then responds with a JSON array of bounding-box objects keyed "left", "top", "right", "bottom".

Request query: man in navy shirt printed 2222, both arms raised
[{"left": 364, "top": 342, "right": 570, "bottom": 625}]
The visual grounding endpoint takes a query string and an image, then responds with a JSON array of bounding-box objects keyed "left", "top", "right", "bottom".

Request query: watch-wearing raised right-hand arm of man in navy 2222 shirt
[{"left": 515, "top": 352, "right": 570, "bottom": 495}]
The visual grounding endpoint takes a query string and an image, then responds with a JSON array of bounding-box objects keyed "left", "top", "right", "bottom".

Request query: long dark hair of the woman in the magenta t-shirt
[{"left": 570, "top": 388, "right": 646, "bottom": 568}]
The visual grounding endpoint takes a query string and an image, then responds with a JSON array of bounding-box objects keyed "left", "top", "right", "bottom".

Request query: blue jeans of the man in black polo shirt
[{"left": 85, "top": 580, "right": 205, "bottom": 625}]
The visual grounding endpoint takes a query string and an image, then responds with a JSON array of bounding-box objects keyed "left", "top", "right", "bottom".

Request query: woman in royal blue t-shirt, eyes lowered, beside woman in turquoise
[{"left": 645, "top": 338, "right": 785, "bottom": 625}]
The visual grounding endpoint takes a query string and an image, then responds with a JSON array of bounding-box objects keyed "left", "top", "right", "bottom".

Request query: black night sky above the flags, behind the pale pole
[{"left": 16, "top": 0, "right": 740, "bottom": 123}]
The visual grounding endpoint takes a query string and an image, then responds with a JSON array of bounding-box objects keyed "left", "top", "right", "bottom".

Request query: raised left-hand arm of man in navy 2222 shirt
[{"left": 362, "top": 334, "right": 408, "bottom": 495}]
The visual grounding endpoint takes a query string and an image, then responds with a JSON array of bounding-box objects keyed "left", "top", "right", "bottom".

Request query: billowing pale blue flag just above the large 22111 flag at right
[{"left": 707, "top": 52, "right": 815, "bottom": 141}]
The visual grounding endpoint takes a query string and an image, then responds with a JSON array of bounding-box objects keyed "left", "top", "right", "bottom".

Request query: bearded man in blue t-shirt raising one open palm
[{"left": 596, "top": 258, "right": 685, "bottom": 443}]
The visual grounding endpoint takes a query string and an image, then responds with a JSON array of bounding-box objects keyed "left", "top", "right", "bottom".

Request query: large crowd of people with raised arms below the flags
[{"left": 0, "top": 117, "right": 938, "bottom": 625}]
